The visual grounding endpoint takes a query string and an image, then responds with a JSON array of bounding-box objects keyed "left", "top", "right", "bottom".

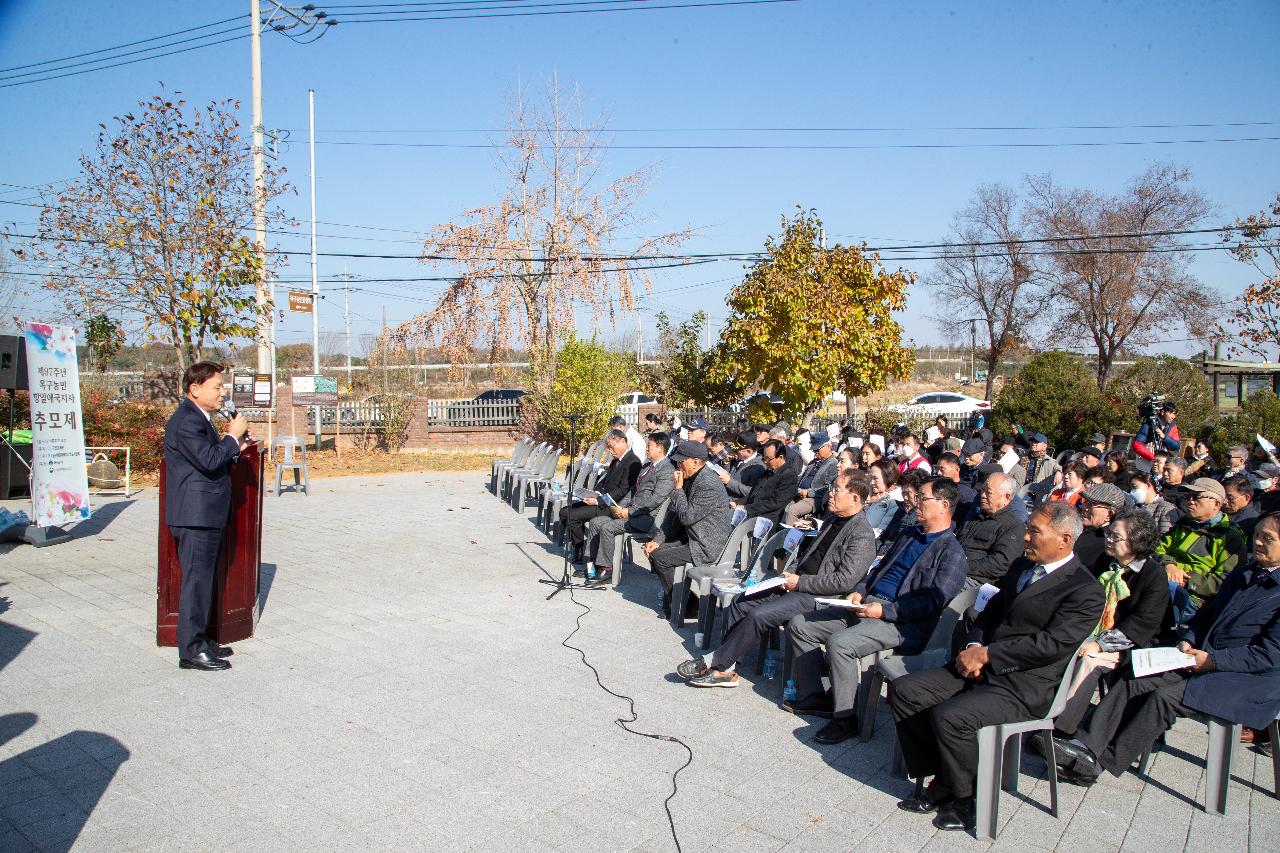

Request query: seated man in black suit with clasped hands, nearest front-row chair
[{"left": 888, "top": 501, "right": 1106, "bottom": 830}]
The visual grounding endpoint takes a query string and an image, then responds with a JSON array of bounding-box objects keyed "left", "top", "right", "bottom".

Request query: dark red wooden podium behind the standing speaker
[{"left": 156, "top": 441, "right": 264, "bottom": 646}]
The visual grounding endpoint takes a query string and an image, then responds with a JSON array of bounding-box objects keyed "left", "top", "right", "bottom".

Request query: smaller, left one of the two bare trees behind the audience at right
[{"left": 924, "top": 184, "right": 1038, "bottom": 400}]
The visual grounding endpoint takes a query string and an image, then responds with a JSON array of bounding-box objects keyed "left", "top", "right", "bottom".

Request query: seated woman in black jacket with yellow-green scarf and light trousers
[{"left": 1036, "top": 507, "right": 1174, "bottom": 747}]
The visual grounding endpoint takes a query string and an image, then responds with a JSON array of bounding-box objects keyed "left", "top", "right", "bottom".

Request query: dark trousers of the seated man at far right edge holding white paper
[{"left": 1075, "top": 670, "right": 1189, "bottom": 776}]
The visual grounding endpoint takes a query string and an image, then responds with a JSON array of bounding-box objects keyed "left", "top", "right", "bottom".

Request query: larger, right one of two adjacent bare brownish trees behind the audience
[{"left": 1027, "top": 164, "right": 1217, "bottom": 388}]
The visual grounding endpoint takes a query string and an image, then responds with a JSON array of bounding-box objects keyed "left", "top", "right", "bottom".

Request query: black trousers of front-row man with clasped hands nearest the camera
[{"left": 888, "top": 663, "right": 1033, "bottom": 798}]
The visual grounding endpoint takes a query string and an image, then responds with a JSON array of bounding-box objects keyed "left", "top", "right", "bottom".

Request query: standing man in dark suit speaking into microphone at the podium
[{"left": 164, "top": 361, "right": 248, "bottom": 671}]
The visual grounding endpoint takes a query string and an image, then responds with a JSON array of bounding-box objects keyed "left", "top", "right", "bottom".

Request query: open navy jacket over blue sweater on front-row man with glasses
[{"left": 854, "top": 528, "right": 969, "bottom": 654}]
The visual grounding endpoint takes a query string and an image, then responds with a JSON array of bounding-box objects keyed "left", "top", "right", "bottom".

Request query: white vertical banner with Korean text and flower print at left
[{"left": 22, "top": 323, "right": 90, "bottom": 528}]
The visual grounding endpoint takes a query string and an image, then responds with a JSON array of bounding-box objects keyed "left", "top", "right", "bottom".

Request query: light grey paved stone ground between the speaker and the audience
[{"left": 0, "top": 474, "right": 1280, "bottom": 853}]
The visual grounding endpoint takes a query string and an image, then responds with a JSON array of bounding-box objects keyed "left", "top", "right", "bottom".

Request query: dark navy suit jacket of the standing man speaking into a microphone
[{"left": 164, "top": 398, "right": 239, "bottom": 528}]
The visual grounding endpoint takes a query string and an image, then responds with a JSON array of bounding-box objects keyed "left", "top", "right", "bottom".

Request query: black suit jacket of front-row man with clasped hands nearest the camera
[{"left": 968, "top": 556, "right": 1106, "bottom": 716}]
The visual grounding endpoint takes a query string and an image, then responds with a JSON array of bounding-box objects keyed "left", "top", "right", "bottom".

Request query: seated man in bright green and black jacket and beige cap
[{"left": 1156, "top": 476, "right": 1247, "bottom": 624}]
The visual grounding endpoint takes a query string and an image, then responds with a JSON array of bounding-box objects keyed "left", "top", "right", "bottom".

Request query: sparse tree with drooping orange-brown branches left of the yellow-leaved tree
[{"left": 393, "top": 79, "right": 689, "bottom": 383}]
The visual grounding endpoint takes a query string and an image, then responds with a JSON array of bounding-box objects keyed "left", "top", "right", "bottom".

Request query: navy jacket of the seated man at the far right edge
[{"left": 1183, "top": 565, "right": 1280, "bottom": 729}]
